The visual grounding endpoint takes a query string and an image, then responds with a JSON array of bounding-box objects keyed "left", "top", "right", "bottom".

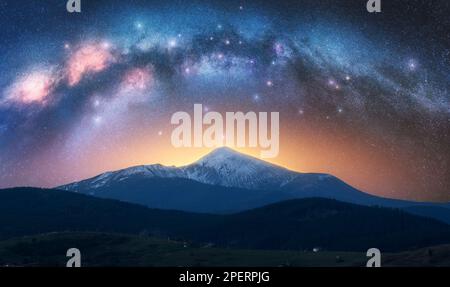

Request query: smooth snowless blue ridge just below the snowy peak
[{"left": 64, "top": 175, "right": 292, "bottom": 214}]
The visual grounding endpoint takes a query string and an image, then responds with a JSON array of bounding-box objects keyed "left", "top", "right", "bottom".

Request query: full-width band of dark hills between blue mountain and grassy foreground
[{"left": 0, "top": 188, "right": 450, "bottom": 251}]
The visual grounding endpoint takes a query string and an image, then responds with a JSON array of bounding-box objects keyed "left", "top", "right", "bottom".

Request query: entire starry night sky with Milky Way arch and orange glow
[{"left": 0, "top": 0, "right": 450, "bottom": 201}]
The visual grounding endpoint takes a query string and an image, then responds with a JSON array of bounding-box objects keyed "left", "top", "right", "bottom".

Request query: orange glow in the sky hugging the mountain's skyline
[{"left": 21, "top": 121, "right": 438, "bottom": 202}]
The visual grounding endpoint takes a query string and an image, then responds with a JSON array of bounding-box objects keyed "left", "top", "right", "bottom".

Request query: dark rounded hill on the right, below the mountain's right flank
[{"left": 211, "top": 198, "right": 448, "bottom": 251}]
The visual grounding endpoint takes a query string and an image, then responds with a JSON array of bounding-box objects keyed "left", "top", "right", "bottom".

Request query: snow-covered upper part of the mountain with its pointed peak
[{"left": 60, "top": 147, "right": 298, "bottom": 194}]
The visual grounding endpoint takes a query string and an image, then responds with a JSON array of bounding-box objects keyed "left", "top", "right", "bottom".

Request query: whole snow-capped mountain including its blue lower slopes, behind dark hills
[{"left": 57, "top": 147, "right": 450, "bottom": 224}]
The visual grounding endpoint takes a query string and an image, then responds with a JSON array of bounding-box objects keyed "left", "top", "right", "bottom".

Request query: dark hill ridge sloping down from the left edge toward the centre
[{"left": 0, "top": 188, "right": 214, "bottom": 239}]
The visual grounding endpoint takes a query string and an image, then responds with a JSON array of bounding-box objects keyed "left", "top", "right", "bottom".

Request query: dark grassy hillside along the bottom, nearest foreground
[{"left": 0, "top": 232, "right": 450, "bottom": 267}]
